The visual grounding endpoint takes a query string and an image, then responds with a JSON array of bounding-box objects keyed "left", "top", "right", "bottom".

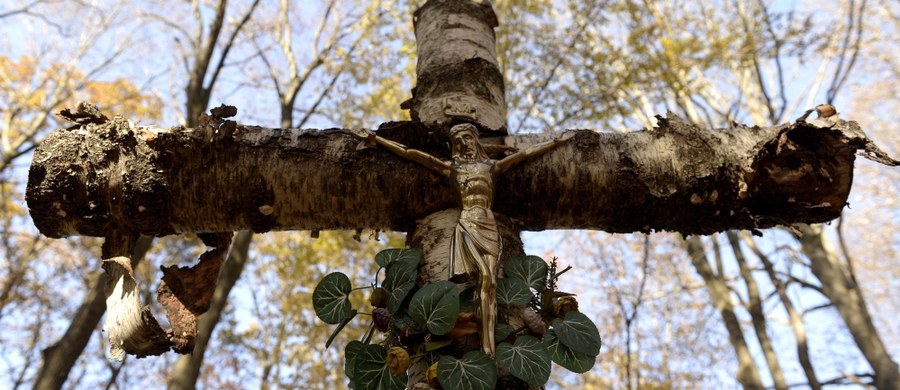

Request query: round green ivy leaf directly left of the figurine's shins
[{"left": 409, "top": 280, "right": 459, "bottom": 335}]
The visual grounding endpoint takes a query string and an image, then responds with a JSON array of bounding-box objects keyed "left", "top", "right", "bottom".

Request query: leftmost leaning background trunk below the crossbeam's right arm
[{"left": 682, "top": 236, "right": 763, "bottom": 390}]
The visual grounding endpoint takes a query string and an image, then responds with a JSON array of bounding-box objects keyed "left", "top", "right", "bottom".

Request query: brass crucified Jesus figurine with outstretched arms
[{"left": 357, "top": 123, "right": 572, "bottom": 357}]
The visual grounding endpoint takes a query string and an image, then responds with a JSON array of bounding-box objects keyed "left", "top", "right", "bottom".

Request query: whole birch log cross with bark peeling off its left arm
[{"left": 27, "top": 0, "right": 898, "bottom": 386}]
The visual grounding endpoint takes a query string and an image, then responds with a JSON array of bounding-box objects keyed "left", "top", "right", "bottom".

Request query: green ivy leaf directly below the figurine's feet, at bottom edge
[{"left": 438, "top": 351, "right": 497, "bottom": 390}]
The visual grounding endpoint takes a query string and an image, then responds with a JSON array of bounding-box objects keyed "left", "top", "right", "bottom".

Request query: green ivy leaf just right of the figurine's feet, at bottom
[{"left": 497, "top": 336, "right": 550, "bottom": 386}]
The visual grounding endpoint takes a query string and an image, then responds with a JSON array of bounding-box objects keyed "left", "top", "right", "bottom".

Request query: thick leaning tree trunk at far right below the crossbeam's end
[{"left": 795, "top": 224, "right": 900, "bottom": 390}]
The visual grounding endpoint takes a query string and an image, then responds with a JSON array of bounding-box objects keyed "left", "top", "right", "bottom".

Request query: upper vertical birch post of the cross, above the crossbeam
[{"left": 401, "top": 0, "right": 506, "bottom": 134}]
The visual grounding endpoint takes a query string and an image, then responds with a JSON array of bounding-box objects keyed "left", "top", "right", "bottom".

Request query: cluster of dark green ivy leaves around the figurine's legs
[{"left": 313, "top": 248, "right": 602, "bottom": 390}]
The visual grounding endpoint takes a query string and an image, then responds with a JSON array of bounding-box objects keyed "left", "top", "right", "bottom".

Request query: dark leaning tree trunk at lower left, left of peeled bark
[{"left": 34, "top": 236, "right": 153, "bottom": 389}]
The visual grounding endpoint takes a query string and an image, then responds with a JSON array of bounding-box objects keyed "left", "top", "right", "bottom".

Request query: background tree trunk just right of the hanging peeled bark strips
[{"left": 168, "top": 230, "right": 253, "bottom": 390}]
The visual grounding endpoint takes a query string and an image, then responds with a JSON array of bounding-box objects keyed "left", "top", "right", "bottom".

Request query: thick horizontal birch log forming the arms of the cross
[{"left": 26, "top": 107, "right": 898, "bottom": 237}]
